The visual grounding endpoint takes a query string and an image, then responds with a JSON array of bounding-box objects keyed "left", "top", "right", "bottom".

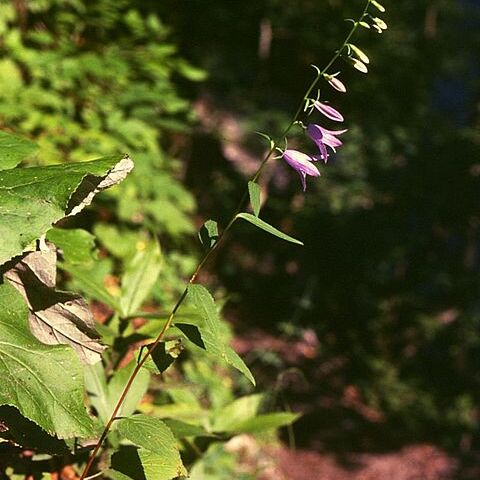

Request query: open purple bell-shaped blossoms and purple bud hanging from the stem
[{"left": 283, "top": 99, "right": 347, "bottom": 191}]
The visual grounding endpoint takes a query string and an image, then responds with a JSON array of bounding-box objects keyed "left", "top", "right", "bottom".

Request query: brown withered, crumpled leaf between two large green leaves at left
[{"left": 4, "top": 243, "right": 105, "bottom": 364}]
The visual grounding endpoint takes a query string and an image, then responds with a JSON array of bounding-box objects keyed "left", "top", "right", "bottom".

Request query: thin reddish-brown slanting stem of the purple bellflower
[{"left": 79, "top": 0, "right": 371, "bottom": 480}]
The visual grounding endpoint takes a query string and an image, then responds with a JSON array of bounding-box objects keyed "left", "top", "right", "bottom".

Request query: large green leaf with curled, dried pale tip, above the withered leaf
[{"left": 0, "top": 156, "right": 133, "bottom": 265}]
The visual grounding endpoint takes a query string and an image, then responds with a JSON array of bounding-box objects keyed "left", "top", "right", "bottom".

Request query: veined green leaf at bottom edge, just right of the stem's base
[{"left": 117, "top": 414, "right": 187, "bottom": 480}]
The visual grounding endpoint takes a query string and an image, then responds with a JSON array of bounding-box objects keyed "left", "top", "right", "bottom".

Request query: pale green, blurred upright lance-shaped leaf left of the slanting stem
[{"left": 120, "top": 241, "right": 161, "bottom": 317}]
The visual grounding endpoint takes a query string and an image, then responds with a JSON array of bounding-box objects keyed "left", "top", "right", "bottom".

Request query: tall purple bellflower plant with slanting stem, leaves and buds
[{"left": 80, "top": 0, "right": 387, "bottom": 480}]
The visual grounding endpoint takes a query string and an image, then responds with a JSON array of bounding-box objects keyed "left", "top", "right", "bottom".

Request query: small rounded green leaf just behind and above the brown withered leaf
[{"left": 47, "top": 227, "right": 96, "bottom": 264}]
